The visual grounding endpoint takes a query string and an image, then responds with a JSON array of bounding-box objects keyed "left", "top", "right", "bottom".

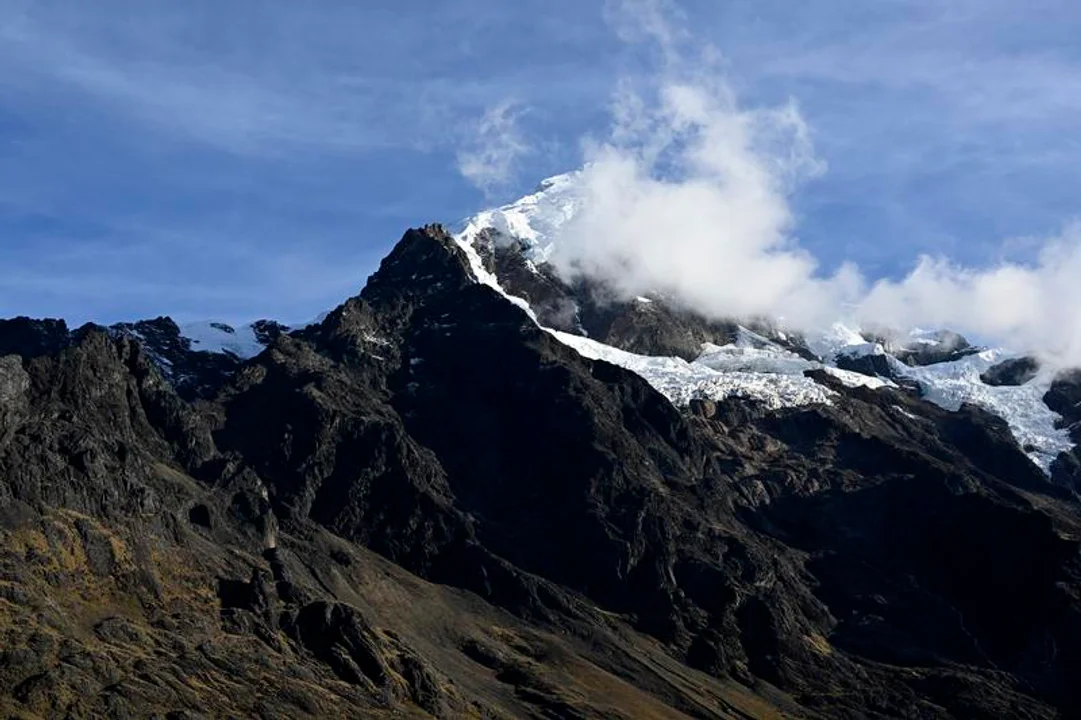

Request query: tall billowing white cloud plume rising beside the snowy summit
[{"left": 552, "top": 2, "right": 857, "bottom": 322}]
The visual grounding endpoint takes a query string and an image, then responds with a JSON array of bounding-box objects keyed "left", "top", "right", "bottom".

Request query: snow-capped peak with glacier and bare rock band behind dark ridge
[{"left": 455, "top": 172, "right": 1073, "bottom": 471}]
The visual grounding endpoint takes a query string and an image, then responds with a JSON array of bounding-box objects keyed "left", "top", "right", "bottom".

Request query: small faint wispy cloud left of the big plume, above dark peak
[{"left": 457, "top": 101, "right": 530, "bottom": 195}]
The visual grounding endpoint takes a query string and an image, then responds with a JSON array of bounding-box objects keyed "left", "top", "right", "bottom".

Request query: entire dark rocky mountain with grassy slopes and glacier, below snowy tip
[{"left": 0, "top": 221, "right": 1081, "bottom": 719}]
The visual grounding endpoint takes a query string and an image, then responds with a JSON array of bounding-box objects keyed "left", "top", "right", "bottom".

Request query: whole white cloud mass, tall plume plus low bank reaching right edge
[{"left": 466, "top": 0, "right": 1081, "bottom": 364}]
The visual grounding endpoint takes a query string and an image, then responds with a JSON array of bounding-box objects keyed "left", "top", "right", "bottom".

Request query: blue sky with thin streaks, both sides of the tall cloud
[{"left": 0, "top": 0, "right": 1081, "bottom": 322}]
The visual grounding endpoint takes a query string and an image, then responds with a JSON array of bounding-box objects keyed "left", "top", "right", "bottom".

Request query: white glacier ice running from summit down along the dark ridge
[{"left": 454, "top": 171, "right": 1073, "bottom": 472}]
